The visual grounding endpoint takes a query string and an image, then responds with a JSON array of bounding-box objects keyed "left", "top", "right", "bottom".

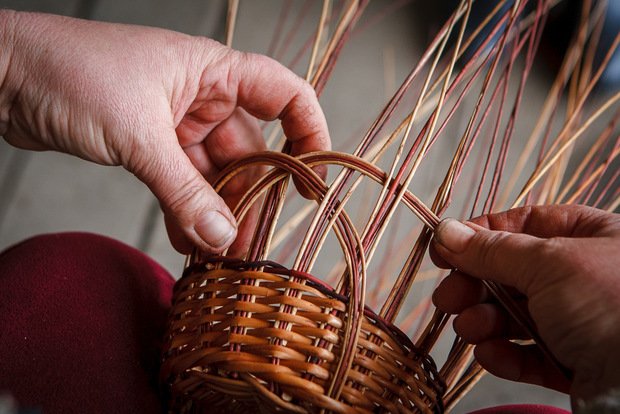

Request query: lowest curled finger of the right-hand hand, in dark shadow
[{"left": 474, "top": 339, "right": 570, "bottom": 393}]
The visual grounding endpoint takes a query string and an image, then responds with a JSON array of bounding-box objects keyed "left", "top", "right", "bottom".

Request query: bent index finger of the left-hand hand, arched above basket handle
[{"left": 231, "top": 54, "right": 331, "bottom": 178}]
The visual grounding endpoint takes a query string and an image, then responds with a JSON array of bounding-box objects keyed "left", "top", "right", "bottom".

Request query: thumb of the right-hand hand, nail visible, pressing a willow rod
[{"left": 433, "top": 219, "right": 545, "bottom": 296}]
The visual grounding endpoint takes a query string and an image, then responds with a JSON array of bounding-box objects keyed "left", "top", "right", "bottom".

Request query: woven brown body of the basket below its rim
[{"left": 162, "top": 259, "right": 443, "bottom": 413}]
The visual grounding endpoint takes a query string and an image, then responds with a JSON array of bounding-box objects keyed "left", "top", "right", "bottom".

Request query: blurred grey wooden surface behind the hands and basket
[{"left": 0, "top": 0, "right": 569, "bottom": 413}]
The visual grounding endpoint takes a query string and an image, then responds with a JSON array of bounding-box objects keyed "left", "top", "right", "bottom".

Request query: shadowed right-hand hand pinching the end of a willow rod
[{"left": 431, "top": 206, "right": 620, "bottom": 398}]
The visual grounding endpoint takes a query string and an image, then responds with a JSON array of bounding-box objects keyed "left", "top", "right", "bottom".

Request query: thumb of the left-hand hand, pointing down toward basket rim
[{"left": 127, "top": 132, "right": 237, "bottom": 253}]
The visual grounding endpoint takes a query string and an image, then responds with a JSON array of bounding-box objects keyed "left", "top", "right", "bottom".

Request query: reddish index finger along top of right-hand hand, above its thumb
[{"left": 471, "top": 205, "right": 620, "bottom": 238}]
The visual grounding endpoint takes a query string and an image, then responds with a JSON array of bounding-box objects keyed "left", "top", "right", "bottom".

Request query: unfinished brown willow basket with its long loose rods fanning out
[{"left": 161, "top": 0, "right": 620, "bottom": 413}]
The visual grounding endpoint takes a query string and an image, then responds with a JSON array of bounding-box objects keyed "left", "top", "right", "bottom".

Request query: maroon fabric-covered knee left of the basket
[{"left": 0, "top": 233, "right": 174, "bottom": 414}]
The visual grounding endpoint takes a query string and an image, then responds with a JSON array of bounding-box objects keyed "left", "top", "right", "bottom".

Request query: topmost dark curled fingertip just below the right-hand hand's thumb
[{"left": 433, "top": 271, "right": 489, "bottom": 314}]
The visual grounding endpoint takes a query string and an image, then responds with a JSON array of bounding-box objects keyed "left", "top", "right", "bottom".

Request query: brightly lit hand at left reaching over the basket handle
[{"left": 0, "top": 11, "right": 330, "bottom": 252}]
